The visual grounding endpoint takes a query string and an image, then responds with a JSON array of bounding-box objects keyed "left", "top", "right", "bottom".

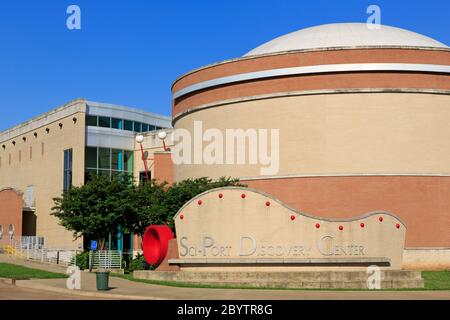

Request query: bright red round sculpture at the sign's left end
[{"left": 142, "top": 224, "right": 174, "bottom": 266}]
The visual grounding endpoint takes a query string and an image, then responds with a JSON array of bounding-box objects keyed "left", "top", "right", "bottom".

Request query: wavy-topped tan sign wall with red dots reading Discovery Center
[{"left": 172, "top": 187, "right": 406, "bottom": 269}]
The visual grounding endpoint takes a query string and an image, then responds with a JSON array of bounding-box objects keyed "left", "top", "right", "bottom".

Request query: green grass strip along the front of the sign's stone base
[{"left": 111, "top": 270, "right": 450, "bottom": 291}]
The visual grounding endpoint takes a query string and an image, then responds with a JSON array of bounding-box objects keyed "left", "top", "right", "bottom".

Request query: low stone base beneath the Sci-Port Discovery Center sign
[{"left": 133, "top": 270, "right": 424, "bottom": 289}]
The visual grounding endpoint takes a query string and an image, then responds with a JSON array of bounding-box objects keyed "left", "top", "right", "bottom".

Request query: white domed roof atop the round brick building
[{"left": 244, "top": 23, "right": 448, "bottom": 57}]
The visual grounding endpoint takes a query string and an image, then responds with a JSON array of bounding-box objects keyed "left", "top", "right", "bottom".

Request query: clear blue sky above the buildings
[{"left": 0, "top": 0, "right": 450, "bottom": 130}]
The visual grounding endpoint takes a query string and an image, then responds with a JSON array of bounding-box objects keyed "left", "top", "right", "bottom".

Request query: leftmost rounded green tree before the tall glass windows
[{"left": 52, "top": 174, "right": 136, "bottom": 249}]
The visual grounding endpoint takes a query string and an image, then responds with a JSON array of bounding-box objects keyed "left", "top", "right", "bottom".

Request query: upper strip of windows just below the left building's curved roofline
[{"left": 86, "top": 115, "right": 163, "bottom": 132}]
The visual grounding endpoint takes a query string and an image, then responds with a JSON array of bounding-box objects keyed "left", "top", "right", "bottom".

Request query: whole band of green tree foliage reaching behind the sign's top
[{"left": 52, "top": 174, "right": 245, "bottom": 248}]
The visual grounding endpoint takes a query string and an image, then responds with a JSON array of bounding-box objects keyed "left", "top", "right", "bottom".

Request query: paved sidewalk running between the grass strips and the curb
[{"left": 0, "top": 255, "right": 450, "bottom": 300}]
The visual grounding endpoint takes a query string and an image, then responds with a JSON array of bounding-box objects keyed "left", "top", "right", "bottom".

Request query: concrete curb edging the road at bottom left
[{"left": 16, "top": 280, "right": 168, "bottom": 300}]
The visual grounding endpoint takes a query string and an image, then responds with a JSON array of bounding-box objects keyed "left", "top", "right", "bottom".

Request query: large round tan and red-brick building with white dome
[{"left": 172, "top": 23, "right": 450, "bottom": 266}]
